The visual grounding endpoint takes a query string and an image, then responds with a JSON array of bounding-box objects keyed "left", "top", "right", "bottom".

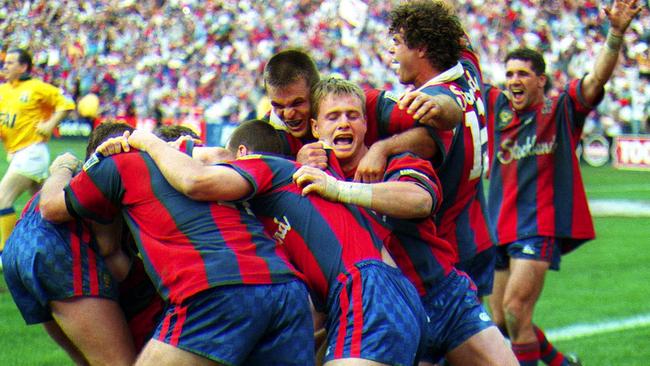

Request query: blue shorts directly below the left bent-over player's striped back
[{"left": 153, "top": 280, "right": 315, "bottom": 366}]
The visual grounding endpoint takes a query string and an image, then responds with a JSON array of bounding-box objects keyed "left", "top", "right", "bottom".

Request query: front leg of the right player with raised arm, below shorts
[{"left": 503, "top": 258, "right": 550, "bottom": 365}]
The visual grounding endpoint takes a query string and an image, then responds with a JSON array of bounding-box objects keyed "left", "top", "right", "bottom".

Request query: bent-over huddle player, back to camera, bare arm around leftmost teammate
[{"left": 40, "top": 124, "right": 314, "bottom": 365}]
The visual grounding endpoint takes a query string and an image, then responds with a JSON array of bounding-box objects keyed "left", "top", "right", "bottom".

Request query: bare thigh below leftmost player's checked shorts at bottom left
[{"left": 50, "top": 297, "right": 136, "bottom": 365}]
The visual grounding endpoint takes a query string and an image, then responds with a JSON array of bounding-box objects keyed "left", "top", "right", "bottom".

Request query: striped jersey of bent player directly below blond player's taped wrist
[{"left": 224, "top": 155, "right": 383, "bottom": 311}]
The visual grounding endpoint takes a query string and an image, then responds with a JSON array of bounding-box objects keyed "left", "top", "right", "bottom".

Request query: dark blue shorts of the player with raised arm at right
[{"left": 496, "top": 236, "right": 562, "bottom": 271}]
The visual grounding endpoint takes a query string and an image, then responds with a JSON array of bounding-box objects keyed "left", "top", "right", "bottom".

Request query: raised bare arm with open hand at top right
[{"left": 582, "top": 0, "right": 643, "bottom": 106}]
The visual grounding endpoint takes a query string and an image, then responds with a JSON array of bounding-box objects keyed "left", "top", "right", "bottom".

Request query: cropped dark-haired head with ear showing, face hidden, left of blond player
[{"left": 226, "top": 119, "right": 286, "bottom": 157}]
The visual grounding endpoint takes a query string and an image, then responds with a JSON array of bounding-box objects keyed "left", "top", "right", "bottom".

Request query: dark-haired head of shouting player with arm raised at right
[{"left": 505, "top": 48, "right": 547, "bottom": 111}]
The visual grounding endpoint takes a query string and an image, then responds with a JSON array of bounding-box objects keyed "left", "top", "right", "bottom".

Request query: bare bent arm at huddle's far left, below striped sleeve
[{"left": 39, "top": 153, "right": 80, "bottom": 223}]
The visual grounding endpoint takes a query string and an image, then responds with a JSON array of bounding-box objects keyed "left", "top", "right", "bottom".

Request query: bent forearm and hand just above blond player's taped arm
[{"left": 354, "top": 127, "right": 438, "bottom": 183}]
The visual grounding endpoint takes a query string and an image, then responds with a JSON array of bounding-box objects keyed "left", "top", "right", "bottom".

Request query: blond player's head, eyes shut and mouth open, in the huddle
[{"left": 311, "top": 77, "right": 367, "bottom": 165}]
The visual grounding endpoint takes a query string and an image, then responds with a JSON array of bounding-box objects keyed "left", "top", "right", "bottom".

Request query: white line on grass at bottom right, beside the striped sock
[{"left": 546, "top": 313, "right": 650, "bottom": 342}]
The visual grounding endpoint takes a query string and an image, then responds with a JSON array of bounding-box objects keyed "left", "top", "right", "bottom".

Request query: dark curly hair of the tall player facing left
[{"left": 389, "top": 0, "right": 465, "bottom": 71}]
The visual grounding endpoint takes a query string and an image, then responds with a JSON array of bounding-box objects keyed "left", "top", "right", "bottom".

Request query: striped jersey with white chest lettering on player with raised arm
[{"left": 487, "top": 80, "right": 595, "bottom": 252}]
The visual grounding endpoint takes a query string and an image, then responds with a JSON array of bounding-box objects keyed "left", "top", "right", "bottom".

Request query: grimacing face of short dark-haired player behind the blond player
[{"left": 267, "top": 79, "right": 311, "bottom": 138}]
